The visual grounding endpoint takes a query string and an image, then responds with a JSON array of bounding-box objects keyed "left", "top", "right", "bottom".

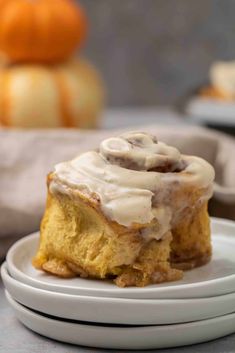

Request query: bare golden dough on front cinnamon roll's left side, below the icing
[{"left": 33, "top": 178, "right": 182, "bottom": 287}]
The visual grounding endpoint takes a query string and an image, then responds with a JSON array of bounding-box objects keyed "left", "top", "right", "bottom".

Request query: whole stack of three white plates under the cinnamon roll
[{"left": 2, "top": 219, "right": 235, "bottom": 349}]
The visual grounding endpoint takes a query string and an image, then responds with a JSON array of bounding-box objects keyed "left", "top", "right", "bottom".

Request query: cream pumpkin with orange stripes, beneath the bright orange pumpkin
[{"left": 0, "top": 59, "right": 104, "bottom": 128}]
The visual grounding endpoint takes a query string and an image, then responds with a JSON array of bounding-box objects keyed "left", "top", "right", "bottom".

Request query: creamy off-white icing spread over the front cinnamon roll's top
[{"left": 51, "top": 132, "right": 214, "bottom": 229}]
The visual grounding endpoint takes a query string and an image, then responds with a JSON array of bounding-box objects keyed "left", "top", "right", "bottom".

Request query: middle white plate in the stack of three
[{"left": 1, "top": 263, "right": 235, "bottom": 325}]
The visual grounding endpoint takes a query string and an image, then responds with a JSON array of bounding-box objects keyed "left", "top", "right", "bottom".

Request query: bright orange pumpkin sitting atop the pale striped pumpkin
[{"left": 0, "top": 0, "right": 87, "bottom": 63}]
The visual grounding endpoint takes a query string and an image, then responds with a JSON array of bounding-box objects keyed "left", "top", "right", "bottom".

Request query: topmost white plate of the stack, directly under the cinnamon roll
[{"left": 7, "top": 219, "right": 235, "bottom": 299}]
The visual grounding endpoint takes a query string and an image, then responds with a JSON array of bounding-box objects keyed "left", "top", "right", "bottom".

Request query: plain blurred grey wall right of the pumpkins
[{"left": 79, "top": 0, "right": 235, "bottom": 106}]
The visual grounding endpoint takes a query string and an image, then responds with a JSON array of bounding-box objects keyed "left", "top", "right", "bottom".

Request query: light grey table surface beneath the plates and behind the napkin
[{"left": 0, "top": 108, "right": 235, "bottom": 353}]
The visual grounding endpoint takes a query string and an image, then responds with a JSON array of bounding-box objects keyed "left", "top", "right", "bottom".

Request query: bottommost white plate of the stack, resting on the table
[{"left": 6, "top": 293, "right": 235, "bottom": 351}]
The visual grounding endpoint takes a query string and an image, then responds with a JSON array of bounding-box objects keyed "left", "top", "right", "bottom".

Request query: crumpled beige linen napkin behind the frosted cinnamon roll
[{"left": 0, "top": 125, "right": 235, "bottom": 258}]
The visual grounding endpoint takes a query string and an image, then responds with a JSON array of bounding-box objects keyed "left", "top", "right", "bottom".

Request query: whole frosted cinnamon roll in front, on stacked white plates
[{"left": 33, "top": 132, "right": 214, "bottom": 287}]
